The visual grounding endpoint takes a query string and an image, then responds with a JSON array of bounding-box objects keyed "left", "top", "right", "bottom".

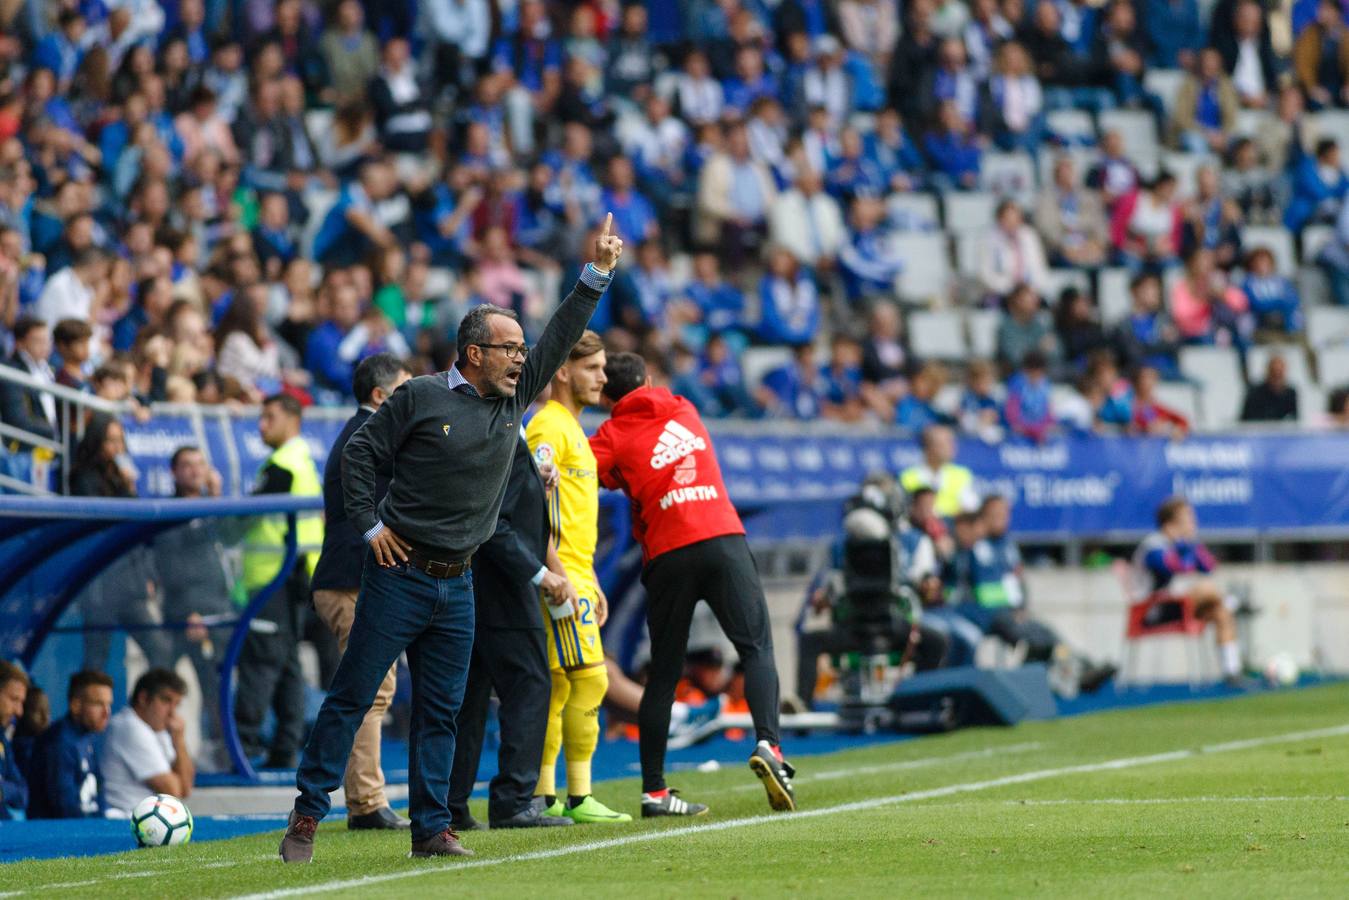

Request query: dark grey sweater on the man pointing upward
[{"left": 341, "top": 271, "right": 602, "bottom": 561}]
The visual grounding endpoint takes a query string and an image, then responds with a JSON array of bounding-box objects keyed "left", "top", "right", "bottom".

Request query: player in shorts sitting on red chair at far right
[{"left": 1130, "top": 497, "right": 1244, "bottom": 687}]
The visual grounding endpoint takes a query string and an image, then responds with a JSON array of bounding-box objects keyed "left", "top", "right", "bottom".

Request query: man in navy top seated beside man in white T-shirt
[{"left": 28, "top": 671, "right": 112, "bottom": 819}]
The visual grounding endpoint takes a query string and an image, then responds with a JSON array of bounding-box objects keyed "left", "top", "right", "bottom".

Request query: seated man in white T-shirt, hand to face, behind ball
[{"left": 98, "top": 669, "right": 197, "bottom": 816}]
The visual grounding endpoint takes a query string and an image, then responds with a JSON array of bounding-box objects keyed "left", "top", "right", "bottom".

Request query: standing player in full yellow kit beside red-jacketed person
[{"left": 525, "top": 331, "right": 633, "bottom": 824}]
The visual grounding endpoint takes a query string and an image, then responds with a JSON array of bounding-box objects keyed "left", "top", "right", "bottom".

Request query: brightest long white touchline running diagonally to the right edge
[{"left": 237, "top": 725, "right": 1349, "bottom": 900}]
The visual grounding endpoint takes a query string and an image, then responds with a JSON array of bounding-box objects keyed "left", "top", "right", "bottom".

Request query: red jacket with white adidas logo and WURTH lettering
[{"left": 591, "top": 387, "right": 745, "bottom": 561}]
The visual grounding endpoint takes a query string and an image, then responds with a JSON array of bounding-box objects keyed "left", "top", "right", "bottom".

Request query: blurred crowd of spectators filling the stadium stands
[{"left": 0, "top": 0, "right": 1349, "bottom": 439}]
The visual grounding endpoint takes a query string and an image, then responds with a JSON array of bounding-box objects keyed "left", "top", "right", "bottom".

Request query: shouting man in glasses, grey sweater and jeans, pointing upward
[{"left": 281, "top": 215, "right": 623, "bottom": 862}]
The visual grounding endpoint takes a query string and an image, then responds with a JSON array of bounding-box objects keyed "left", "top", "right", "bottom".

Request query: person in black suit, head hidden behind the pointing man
[{"left": 449, "top": 440, "right": 576, "bottom": 830}]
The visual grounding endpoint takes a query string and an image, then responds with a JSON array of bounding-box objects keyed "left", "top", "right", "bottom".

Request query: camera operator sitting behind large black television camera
[{"left": 796, "top": 475, "right": 947, "bottom": 708}]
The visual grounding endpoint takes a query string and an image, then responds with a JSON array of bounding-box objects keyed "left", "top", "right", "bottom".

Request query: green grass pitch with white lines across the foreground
[{"left": 0, "top": 684, "right": 1349, "bottom": 900}]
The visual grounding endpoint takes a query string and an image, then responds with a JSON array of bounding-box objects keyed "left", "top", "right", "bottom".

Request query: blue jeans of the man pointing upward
[{"left": 295, "top": 553, "right": 473, "bottom": 841}]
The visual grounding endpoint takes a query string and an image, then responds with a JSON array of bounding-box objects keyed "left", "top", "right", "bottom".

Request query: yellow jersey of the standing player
[{"left": 525, "top": 401, "right": 599, "bottom": 580}]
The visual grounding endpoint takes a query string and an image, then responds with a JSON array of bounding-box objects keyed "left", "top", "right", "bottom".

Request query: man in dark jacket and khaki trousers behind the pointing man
[{"left": 310, "top": 354, "right": 411, "bottom": 830}]
